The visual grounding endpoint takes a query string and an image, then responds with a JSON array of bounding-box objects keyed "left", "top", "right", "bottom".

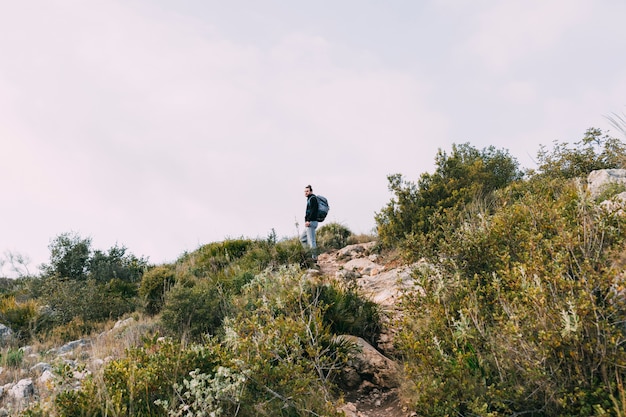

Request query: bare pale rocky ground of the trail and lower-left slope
[{"left": 0, "top": 242, "right": 420, "bottom": 417}]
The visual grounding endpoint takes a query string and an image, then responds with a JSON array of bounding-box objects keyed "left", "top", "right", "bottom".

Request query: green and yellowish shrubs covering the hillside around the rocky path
[{"left": 0, "top": 129, "right": 626, "bottom": 417}]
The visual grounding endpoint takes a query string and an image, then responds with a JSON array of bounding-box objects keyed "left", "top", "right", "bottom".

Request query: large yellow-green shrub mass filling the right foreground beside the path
[{"left": 397, "top": 178, "right": 626, "bottom": 416}]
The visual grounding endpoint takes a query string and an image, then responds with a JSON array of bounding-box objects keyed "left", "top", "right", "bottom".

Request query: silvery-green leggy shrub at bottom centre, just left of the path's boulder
[{"left": 223, "top": 267, "right": 354, "bottom": 417}]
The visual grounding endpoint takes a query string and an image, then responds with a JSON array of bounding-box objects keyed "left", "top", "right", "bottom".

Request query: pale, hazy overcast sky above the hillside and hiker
[{"left": 0, "top": 0, "right": 626, "bottom": 276}]
